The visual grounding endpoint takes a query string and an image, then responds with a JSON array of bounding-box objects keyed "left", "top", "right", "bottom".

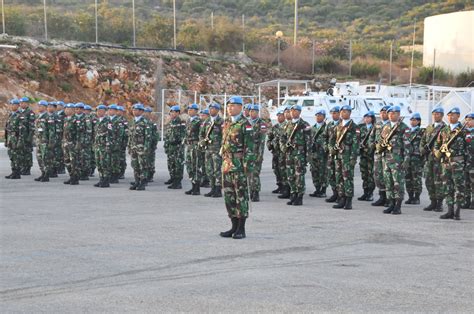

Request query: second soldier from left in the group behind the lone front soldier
[{"left": 184, "top": 104, "right": 202, "bottom": 195}]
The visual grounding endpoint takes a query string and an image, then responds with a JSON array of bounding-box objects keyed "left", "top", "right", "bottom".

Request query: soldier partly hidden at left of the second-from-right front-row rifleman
[{"left": 371, "top": 105, "right": 390, "bottom": 206}]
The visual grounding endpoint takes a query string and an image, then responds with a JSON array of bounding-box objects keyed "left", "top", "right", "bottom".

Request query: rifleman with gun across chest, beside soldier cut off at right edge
[{"left": 434, "top": 107, "right": 469, "bottom": 220}]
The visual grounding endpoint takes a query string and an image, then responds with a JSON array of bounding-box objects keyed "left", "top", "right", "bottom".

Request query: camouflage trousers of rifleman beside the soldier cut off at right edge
[{"left": 442, "top": 156, "right": 466, "bottom": 206}]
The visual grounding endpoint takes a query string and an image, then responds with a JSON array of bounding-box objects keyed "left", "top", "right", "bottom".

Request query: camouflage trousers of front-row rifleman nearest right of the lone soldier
[{"left": 285, "top": 150, "right": 306, "bottom": 196}]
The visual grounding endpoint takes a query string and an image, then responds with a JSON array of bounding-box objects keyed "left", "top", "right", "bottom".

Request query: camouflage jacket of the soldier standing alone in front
[{"left": 221, "top": 115, "right": 256, "bottom": 173}]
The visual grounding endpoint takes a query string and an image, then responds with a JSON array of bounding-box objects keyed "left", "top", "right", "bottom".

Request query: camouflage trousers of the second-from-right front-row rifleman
[{"left": 383, "top": 157, "right": 405, "bottom": 200}]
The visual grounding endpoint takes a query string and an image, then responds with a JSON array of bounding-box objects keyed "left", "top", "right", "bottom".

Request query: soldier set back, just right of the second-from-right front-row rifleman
[{"left": 405, "top": 112, "right": 425, "bottom": 205}]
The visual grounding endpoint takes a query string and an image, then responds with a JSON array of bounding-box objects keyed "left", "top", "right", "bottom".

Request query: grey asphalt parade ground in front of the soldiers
[{"left": 0, "top": 147, "right": 474, "bottom": 313}]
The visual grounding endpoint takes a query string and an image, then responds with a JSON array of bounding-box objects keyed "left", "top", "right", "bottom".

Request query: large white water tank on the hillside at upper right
[{"left": 423, "top": 11, "right": 474, "bottom": 74}]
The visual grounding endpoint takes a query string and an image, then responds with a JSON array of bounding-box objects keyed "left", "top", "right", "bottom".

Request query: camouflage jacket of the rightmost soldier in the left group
[{"left": 128, "top": 116, "right": 153, "bottom": 153}]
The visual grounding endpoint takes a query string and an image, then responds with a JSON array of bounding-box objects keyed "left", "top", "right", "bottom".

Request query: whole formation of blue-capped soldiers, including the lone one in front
[{"left": 5, "top": 97, "right": 474, "bottom": 239}]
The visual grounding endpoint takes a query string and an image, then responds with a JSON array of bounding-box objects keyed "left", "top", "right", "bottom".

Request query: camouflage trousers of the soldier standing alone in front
[{"left": 224, "top": 172, "right": 249, "bottom": 218}]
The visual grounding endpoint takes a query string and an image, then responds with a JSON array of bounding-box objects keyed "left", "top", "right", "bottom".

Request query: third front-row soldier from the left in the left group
[{"left": 63, "top": 103, "right": 80, "bottom": 185}]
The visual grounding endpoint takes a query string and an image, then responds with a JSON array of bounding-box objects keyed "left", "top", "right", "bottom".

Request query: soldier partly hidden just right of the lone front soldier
[{"left": 248, "top": 104, "right": 267, "bottom": 202}]
